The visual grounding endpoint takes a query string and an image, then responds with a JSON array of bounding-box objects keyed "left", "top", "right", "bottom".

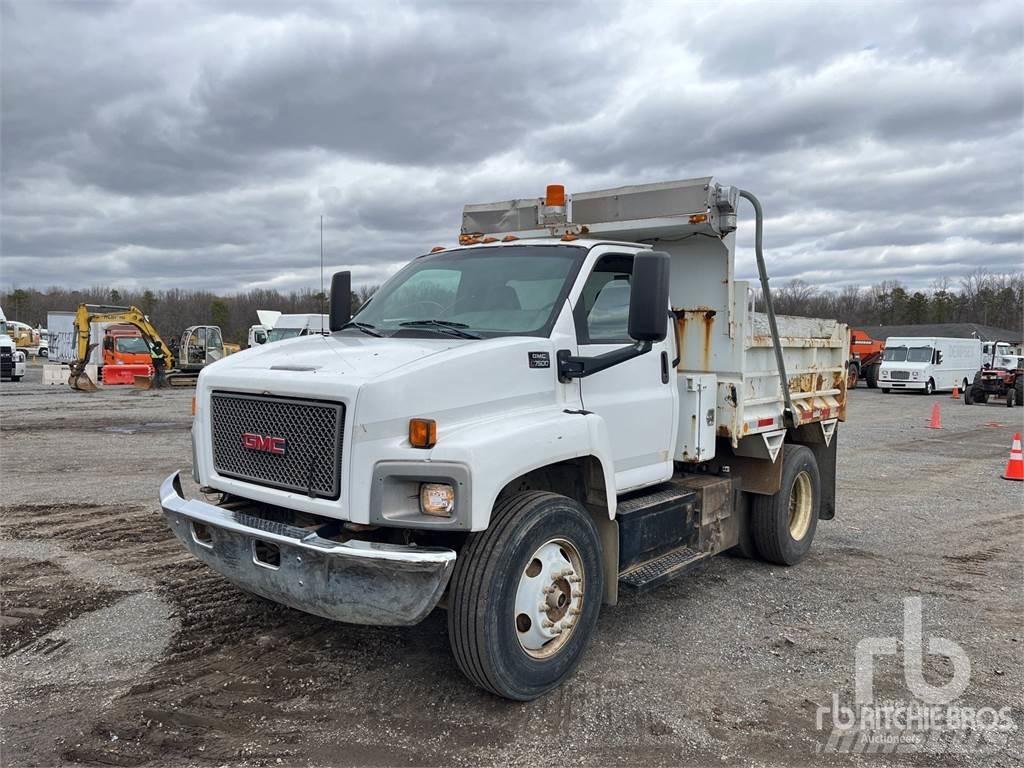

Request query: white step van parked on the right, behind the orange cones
[{"left": 879, "top": 336, "right": 981, "bottom": 394}]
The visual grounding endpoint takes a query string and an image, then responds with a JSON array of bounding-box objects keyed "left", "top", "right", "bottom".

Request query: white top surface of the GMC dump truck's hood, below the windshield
[{"left": 208, "top": 334, "right": 471, "bottom": 383}]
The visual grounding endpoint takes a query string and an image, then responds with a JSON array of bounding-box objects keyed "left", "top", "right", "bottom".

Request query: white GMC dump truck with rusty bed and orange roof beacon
[{"left": 160, "top": 177, "right": 848, "bottom": 700}]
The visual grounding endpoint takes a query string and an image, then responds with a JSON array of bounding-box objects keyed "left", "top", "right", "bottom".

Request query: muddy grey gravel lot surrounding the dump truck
[{"left": 0, "top": 367, "right": 1024, "bottom": 766}]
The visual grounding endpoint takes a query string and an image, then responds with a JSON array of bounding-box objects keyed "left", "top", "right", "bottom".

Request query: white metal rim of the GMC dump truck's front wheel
[{"left": 512, "top": 539, "right": 587, "bottom": 658}]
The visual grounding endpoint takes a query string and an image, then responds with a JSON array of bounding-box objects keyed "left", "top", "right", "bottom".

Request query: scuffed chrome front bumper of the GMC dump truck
[{"left": 160, "top": 472, "right": 456, "bottom": 625}]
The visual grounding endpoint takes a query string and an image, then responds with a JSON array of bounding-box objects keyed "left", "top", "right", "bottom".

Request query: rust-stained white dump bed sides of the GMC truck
[{"left": 676, "top": 299, "right": 849, "bottom": 447}]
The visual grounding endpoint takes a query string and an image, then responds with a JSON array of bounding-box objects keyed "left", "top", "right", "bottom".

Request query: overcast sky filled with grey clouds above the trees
[{"left": 0, "top": 0, "right": 1024, "bottom": 292}]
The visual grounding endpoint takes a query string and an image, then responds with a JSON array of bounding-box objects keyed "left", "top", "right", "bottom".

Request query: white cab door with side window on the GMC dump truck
[{"left": 574, "top": 253, "right": 677, "bottom": 493}]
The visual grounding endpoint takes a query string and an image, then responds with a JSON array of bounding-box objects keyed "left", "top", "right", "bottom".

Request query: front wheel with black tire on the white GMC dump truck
[{"left": 449, "top": 490, "right": 604, "bottom": 701}]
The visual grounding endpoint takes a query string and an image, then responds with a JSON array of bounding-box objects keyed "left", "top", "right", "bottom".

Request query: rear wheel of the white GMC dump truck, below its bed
[{"left": 751, "top": 443, "right": 821, "bottom": 565}]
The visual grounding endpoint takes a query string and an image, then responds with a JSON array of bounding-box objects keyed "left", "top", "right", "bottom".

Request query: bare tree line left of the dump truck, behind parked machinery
[{"left": 0, "top": 286, "right": 377, "bottom": 346}]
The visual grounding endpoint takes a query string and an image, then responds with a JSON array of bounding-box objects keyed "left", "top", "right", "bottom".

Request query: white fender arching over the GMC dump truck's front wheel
[{"left": 430, "top": 408, "right": 615, "bottom": 530}]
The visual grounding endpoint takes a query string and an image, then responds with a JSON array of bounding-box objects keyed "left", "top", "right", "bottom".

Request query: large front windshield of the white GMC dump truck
[{"left": 353, "top": 246, "right": 586, "bottom": 338}]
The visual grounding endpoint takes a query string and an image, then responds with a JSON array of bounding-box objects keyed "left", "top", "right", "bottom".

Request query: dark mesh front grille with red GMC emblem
[{"left": 210, "top": 392, "right": 345, "bottom": 499}]
